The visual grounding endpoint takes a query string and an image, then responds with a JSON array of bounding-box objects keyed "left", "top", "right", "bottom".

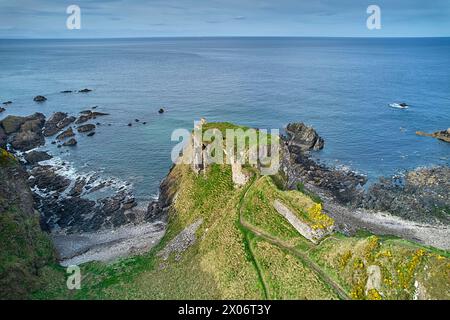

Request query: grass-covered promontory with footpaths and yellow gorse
[{"left": 18, "top": 123, "right": 450, "bottom": 299}]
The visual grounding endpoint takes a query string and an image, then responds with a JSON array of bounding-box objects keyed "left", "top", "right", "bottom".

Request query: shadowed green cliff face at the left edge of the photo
[{"left": 0, "top": 149, "right": 54, "bottom": 299}]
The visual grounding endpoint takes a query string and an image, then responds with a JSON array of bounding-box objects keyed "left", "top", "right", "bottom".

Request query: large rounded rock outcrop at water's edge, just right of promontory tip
[{"left": 286, "top": 123, "right": 324, "bottom": 153}]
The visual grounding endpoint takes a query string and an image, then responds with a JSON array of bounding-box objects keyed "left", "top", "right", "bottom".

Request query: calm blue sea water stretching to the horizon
[{"left": 0, "top": 38, "right": 450, "bottom": 198}]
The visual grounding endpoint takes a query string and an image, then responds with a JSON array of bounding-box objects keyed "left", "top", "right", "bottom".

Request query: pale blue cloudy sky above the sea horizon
[{"left": 0, "top": 0, "right": 450, "bottom": 38}]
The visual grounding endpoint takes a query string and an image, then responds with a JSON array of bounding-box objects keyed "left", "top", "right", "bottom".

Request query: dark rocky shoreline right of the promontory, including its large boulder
[{"left": 282, "top": 124, "right": 450, "bottom": 225}]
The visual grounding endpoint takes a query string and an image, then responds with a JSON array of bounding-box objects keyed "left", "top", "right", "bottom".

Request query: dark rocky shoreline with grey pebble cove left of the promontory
[{"left": 0, "top": 100, "right": 168, "bottom": 265}]
